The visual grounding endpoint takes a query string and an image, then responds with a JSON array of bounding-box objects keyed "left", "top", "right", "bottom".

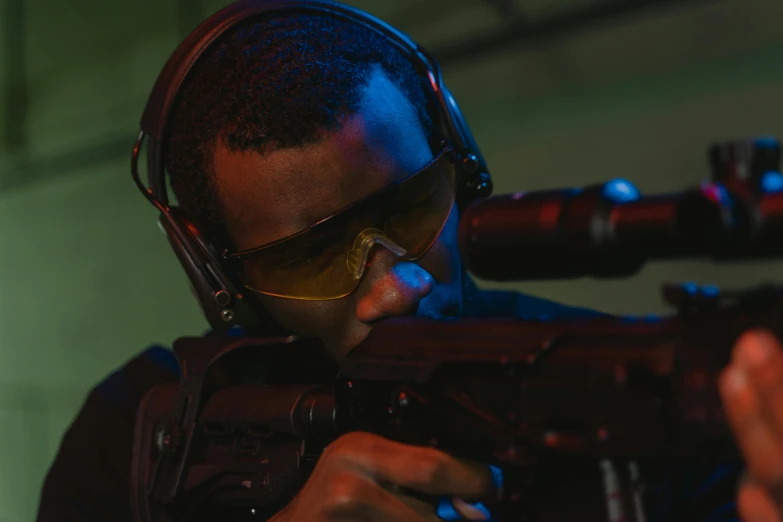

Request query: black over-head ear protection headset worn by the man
[{"left": 131, "top": 0, "right": 492, "bottom": 331}]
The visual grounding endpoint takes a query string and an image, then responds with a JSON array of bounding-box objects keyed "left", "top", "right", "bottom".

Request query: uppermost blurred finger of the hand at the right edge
[{"left": 733, "top": 331, "right": 783, "bottom": 442}]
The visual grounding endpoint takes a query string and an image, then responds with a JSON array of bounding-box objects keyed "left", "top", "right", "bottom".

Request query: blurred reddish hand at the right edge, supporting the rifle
[{"left": 719, "top": 331, "right": 783, "bottom": 522}]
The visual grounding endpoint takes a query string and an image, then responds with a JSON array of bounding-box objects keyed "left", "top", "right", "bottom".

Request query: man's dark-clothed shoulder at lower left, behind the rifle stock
[{"left": 37, "top": 346, "right": 179, "bottom": 522}]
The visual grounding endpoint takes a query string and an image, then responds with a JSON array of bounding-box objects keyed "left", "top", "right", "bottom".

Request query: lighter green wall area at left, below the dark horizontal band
[{"left": 0, "top": 158, "right": 206, "bottom": 522}]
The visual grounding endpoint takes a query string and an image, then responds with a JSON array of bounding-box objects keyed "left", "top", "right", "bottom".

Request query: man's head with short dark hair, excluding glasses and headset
[{"left": 165, "top": 14, "right": 463, "bottom": 357}]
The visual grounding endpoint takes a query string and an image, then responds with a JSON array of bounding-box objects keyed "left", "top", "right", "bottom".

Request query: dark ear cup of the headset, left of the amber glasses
[{"left": 158, "top": 208, "right": 260, "bottom": 331}]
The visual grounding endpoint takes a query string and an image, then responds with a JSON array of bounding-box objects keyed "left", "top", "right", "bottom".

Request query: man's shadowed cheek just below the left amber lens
[{"left": 258, "top": 295, "right": 350, "bottom": 340}]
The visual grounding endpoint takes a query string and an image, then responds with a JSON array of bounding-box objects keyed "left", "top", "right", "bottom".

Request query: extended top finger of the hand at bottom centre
[{"left": 332, "top": 433, "right": 493, "bottom": 498}]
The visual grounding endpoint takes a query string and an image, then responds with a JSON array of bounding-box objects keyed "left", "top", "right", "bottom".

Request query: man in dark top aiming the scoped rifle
[{"left": 38, "top": 4, "right": 783, "bottom": 522}]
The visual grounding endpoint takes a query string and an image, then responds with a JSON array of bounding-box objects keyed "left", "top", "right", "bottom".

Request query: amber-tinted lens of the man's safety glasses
[{"left": 239, "top": 151, "right": 455, "bottom": 300}]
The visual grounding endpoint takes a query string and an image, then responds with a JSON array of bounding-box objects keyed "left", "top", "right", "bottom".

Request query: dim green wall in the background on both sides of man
[{"left": 0, "top": 0, "right": 783, "bottom": 522}]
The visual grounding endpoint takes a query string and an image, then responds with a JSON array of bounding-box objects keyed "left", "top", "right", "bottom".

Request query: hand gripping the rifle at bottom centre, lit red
[{"left": 270, "top": 432, "right": 493, "bottom": 522}]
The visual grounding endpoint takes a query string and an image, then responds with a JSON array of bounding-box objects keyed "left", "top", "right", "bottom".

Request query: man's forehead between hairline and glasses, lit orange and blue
[{"left": 214, "top": 68, "right": 432, "bottom": 250}]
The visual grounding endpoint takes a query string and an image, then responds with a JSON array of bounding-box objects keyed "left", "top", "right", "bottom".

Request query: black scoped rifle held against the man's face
[{"left": 132, "top": 140, "right": 783, "bottom": 522}]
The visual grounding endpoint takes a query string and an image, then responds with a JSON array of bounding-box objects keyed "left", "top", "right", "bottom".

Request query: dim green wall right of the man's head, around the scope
[{"left": 451, "top": 0, "right": 783, "bottom": 313}]
